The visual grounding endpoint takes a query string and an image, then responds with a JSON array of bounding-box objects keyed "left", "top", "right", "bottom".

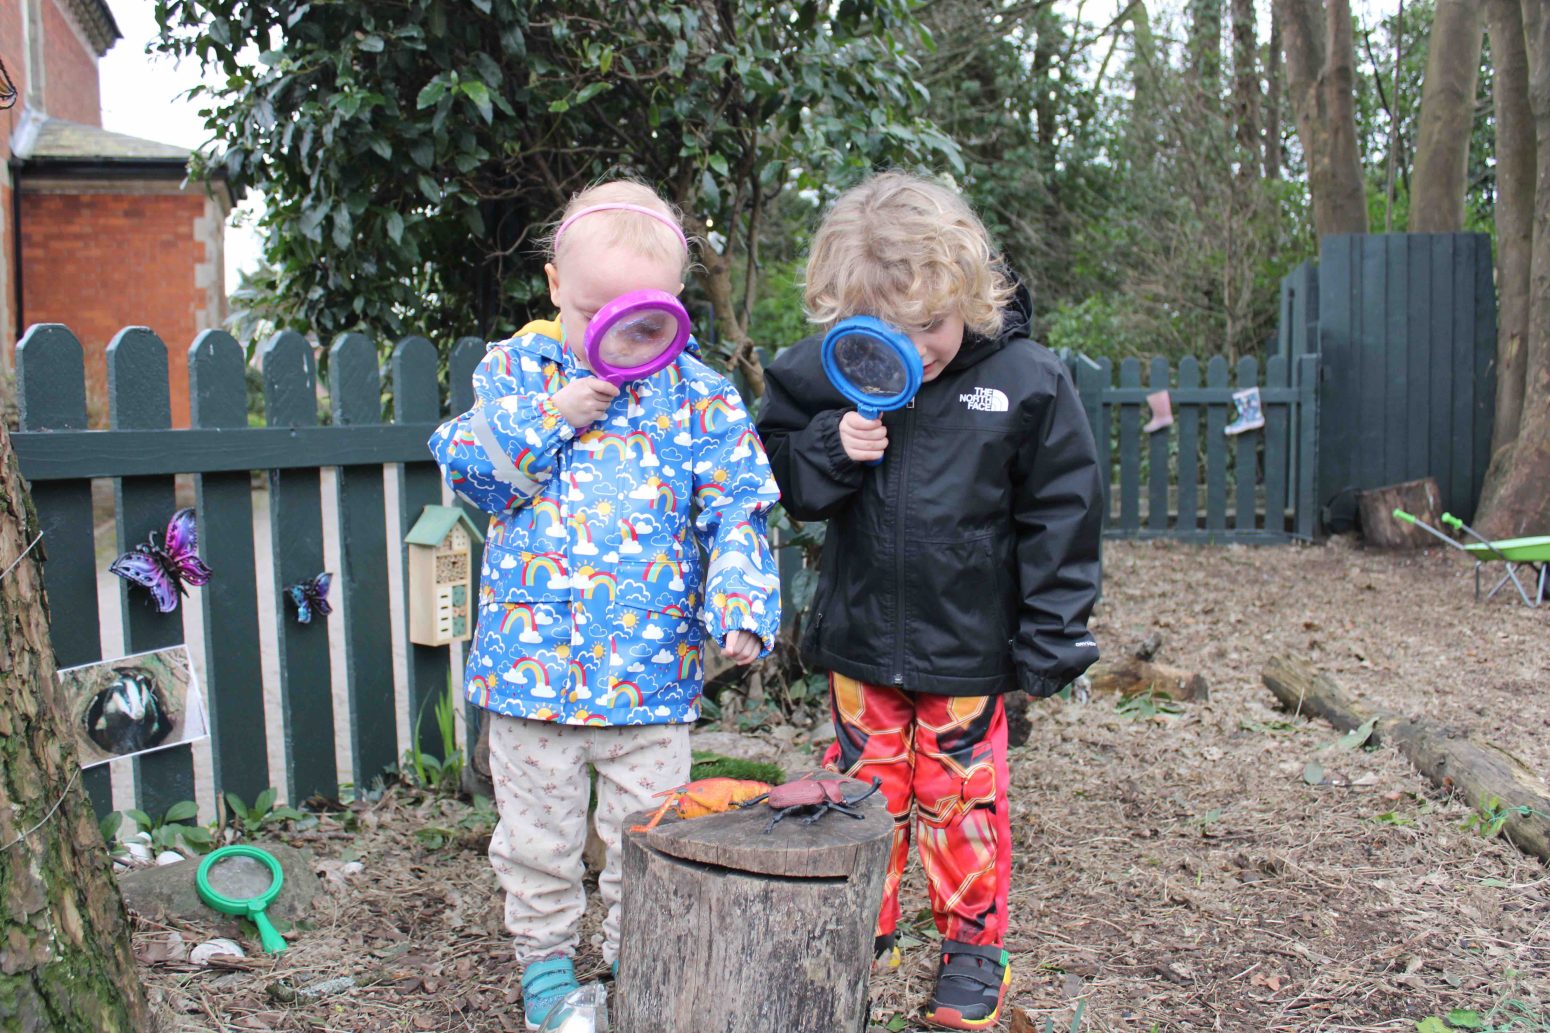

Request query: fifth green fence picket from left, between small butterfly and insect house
[{"left": 329, "top": 333, "right": 398, "bottom": 788}]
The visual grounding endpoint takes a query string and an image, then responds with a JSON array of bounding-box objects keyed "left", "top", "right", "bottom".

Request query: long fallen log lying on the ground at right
[{"left": 1260, "top": 656, "right": 1550, "bottom": 861}]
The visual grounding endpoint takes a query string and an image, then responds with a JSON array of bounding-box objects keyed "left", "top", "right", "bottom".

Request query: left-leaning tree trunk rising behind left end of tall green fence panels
[{"left": 1274, "top": 0, "right": 1367, "bottom": 236}]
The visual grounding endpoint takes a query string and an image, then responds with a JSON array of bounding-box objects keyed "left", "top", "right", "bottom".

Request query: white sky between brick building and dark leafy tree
[{"left": 98, "top": 0, "right": 259, "bottom": 293}]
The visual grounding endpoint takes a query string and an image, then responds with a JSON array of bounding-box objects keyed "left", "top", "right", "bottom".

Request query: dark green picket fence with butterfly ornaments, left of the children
[{"left": 14, "top": 324, "right": 485, "bottom": 814}]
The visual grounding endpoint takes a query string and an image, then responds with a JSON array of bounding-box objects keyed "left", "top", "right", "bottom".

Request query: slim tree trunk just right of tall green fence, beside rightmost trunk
[{"left": 1485, "top": 0, "right": 1535, "bottom": 468}]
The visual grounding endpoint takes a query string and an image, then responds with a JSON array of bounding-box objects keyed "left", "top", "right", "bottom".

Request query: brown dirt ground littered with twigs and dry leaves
[{"left": 136, "top": 541, "right": 1550, "bottom": 1033}]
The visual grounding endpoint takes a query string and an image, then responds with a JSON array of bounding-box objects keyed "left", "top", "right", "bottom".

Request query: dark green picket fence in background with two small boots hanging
[{"left": 1071, "top": 355, "right": 1318, "bottom": 543}]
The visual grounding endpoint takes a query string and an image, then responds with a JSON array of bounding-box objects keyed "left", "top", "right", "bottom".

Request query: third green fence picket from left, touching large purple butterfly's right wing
[{"left": 189, "top": 330, "right": 270, "bottom": 803}]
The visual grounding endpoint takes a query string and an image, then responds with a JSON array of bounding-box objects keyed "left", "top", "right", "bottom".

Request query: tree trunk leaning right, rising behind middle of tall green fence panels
[{"left": 1411, "top": 0, "right": 1483, "bottom": 233}]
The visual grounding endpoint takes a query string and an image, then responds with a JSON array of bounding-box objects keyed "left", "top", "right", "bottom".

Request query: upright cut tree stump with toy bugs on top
[{"left": 614, "top": 772, "right": 893, "bottom": 1033}]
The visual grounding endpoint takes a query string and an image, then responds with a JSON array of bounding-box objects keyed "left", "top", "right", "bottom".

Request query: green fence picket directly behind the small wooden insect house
[{"left": 391, "top": 337, "right": 451, "bottom": 757}]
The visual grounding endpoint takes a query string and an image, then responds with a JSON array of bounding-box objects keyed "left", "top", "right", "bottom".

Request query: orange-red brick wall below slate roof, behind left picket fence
[{"left": 22, "top": 186, "right": 215, "bottom": 427}]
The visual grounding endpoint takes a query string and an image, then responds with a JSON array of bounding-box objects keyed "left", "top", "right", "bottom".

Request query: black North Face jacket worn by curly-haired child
[{"left": 758, "top": 290, "right": 1101, "bottom": 696}]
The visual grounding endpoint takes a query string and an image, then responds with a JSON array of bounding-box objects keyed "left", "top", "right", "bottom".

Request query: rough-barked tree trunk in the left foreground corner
[{"left": 0, "top": 427, "right": 153, "bottom": 1033}]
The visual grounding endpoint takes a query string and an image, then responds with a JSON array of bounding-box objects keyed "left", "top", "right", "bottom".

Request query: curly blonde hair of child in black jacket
[{"left": 804, "top": 172, "right": 1014, "bottom": 337}]
